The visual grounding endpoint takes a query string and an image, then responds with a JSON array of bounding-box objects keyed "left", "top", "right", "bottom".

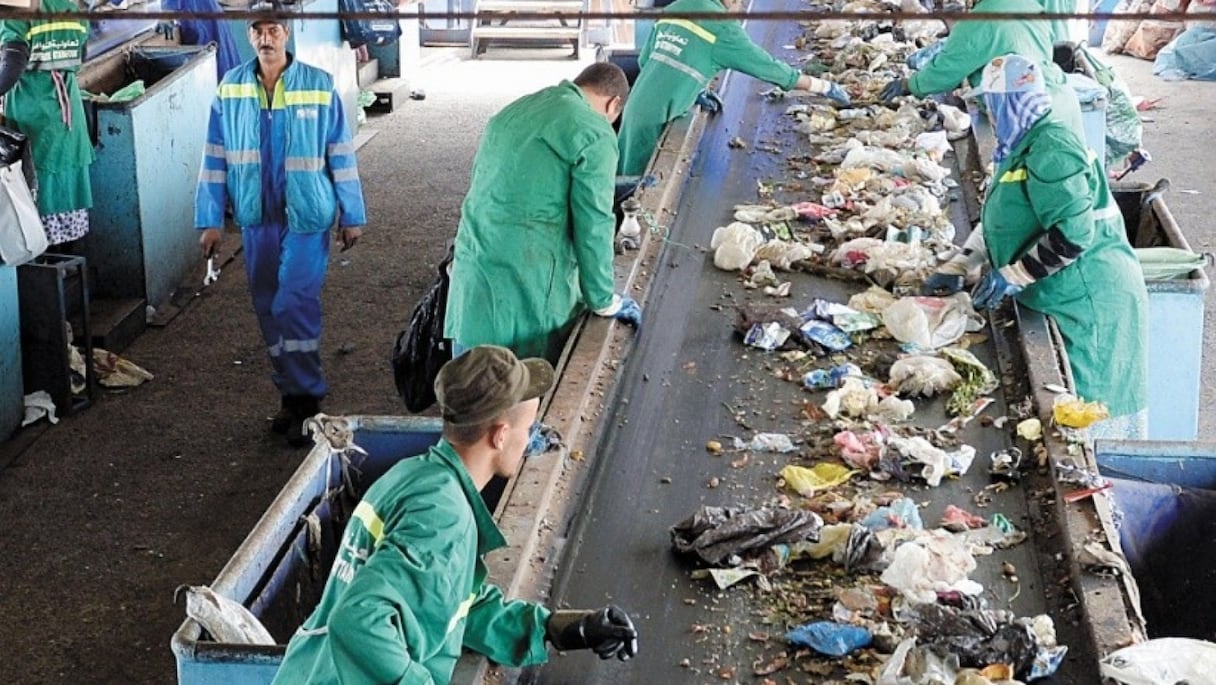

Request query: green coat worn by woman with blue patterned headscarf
[{"left": 983, "top": 118, "right": 1148, "bottom": 416}]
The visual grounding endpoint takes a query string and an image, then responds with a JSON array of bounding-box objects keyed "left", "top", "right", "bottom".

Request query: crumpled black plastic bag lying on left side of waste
[{"left": 671, "top": 506, "right": 823, "bottom": 566}]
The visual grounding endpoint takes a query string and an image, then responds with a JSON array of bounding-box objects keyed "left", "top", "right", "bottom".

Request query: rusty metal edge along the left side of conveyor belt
[{"left": 451, "top": 99, "right": 705, "bottom": 685}]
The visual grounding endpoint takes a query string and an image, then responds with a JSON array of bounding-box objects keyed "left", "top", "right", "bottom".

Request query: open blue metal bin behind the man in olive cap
[{"left": 170, "top": 416, "right": 443, "bottom": 685}]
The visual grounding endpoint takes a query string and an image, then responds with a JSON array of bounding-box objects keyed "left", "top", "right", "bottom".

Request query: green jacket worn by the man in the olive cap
[{"left": 275, "top": 440, "right": 550, "bottom": 685}]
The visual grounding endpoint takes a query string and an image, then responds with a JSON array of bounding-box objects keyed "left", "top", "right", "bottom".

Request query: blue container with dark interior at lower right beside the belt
[{"left": 1094, "top": 440, "right": 1216, "bottom": 640}]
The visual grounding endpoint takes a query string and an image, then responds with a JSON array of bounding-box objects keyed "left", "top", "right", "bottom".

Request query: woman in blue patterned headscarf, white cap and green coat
[{"left": 925, "top": 55, "right": 1148, "bottom": 439}]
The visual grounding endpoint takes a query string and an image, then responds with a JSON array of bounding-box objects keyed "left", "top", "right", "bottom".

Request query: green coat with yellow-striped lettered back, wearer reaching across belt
[{"left": 618, "top": 0, "right": 800, "bottom": 176}]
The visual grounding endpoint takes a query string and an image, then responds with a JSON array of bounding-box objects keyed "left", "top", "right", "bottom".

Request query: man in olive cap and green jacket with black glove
[{"left": 275, "top": 346, "right": 637, "bottom": 685}]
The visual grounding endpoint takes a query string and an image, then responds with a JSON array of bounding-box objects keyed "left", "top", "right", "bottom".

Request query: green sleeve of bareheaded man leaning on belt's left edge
[{"left": 570, "top": 130, "right": 620, "bottom": 311}]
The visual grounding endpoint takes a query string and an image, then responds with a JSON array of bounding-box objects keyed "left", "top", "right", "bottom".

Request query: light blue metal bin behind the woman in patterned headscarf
[{"left": 1111, "top": 184, "right": 1209, "bottom": 440}]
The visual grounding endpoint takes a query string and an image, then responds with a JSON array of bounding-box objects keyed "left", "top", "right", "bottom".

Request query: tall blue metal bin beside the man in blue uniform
[{"left": 86, "top": 46, "right": 215, "bottom": 305}]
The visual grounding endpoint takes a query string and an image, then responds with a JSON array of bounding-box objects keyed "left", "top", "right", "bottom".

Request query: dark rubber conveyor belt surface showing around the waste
[{"left": 524, "top": 0, "right": 1092, "bottom": 684}]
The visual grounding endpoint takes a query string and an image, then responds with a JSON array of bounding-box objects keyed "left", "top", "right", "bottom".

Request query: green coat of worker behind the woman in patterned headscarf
[{"left": 908, "top": 0, "right": 1085, "bottom": 140}]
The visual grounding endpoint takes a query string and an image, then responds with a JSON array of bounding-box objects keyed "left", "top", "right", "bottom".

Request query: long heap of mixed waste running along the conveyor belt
[{"left": 671, "top": 0, "right": 1123, "bottom": 685}]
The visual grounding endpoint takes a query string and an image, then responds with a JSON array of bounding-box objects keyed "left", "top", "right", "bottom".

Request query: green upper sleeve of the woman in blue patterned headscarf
[{"left": 1026, "top": 131, "right": 1094, "bottom": 251}]
